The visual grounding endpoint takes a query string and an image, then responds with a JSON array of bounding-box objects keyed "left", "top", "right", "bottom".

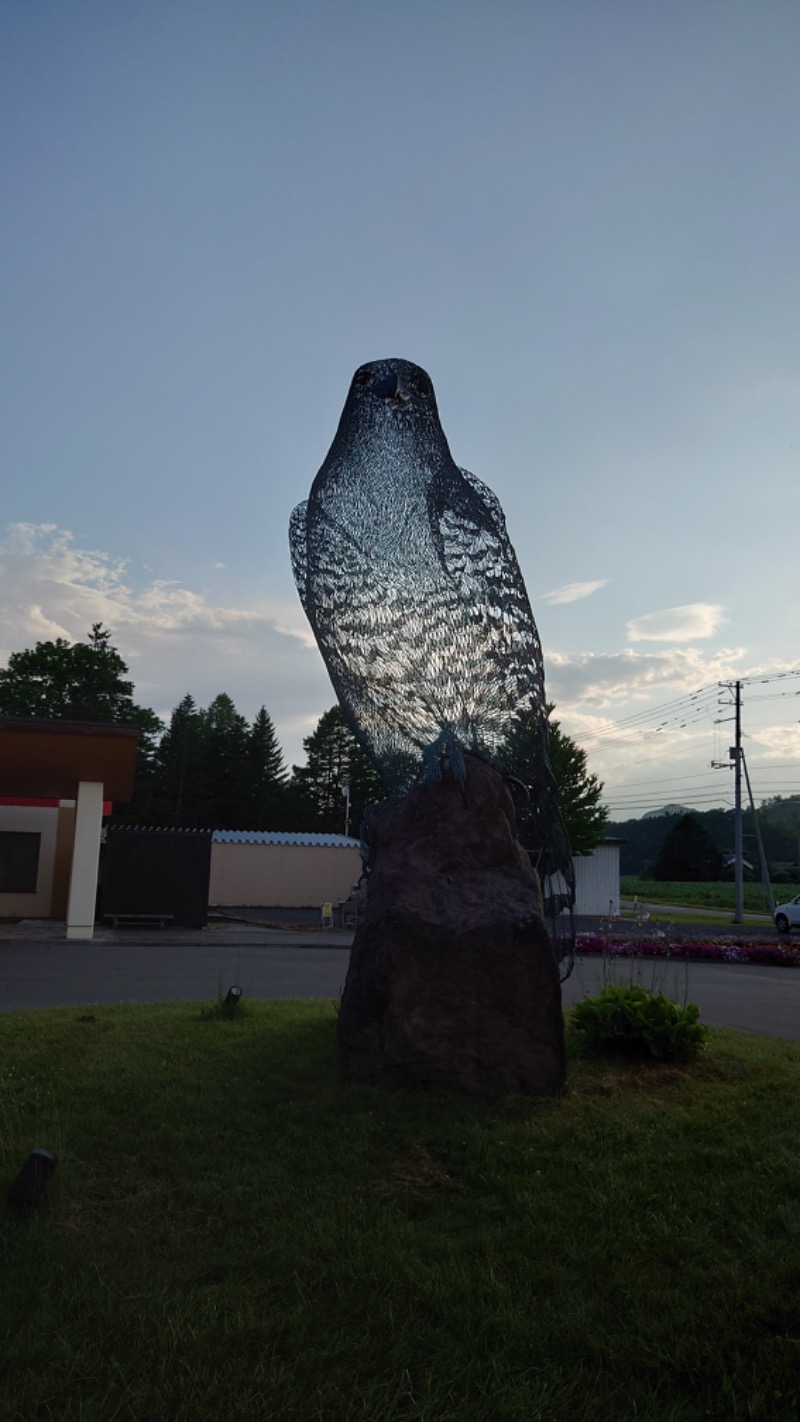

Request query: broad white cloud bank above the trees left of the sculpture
[{"left": 0, "top": 523, "right": 335, "bottom": 761}]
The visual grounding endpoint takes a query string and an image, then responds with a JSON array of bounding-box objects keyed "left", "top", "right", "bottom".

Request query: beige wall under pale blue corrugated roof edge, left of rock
[{"left": 209, "top": 845, "right": 361, "bottom": 909}]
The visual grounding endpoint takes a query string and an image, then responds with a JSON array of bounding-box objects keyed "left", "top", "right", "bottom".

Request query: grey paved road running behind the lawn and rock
[{"left": 0, "top": 929, "right": 800, "bottom": 1039}]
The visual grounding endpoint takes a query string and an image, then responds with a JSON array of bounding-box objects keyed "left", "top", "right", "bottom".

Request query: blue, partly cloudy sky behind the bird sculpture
[{"left": 0, "top": 0, "right": 800, "bottom": 812}]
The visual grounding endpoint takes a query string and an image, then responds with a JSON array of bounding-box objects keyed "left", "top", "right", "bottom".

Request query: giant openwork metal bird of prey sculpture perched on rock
[{"left": 290, "top": 360, "right": 573, "bottom": 955}]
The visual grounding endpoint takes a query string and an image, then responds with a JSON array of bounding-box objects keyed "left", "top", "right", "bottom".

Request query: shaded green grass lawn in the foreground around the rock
[{"left": 0, "top": 1003, "right": 800, "bottom": 1422}]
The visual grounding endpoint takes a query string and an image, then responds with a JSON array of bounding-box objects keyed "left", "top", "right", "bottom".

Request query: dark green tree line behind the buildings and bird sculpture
[{"left": 0, "top": 623, "right": 607, "bottom": 853}]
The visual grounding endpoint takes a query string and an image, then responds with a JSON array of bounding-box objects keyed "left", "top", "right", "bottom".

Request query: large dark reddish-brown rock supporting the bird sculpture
[{"left": 338, "top": 755, "right": 566, "bottom": 1099}]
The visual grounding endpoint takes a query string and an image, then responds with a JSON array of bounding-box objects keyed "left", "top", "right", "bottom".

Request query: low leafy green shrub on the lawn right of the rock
[{"left": 571, "top": 983, "right": 708, "bottom": 1061}]
